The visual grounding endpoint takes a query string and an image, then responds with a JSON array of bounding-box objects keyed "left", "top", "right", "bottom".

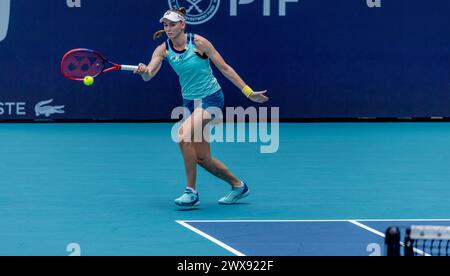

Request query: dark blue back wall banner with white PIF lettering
[{"left": 0, "top": 0, "right": 450, "bottom": 120}]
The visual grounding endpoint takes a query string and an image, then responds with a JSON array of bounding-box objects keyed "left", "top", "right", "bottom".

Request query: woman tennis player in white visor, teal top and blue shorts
[{"left": 135, "top": 8, "right": 268, "bottom": 207}]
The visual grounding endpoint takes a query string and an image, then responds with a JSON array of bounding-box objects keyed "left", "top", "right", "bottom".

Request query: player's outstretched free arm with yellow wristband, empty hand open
[{"left": 195, "top": 35, "right": 269, "bottom": 103}]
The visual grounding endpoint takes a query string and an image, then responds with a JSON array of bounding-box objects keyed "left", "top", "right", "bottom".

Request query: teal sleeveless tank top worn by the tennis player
[{"left": 166, "top": 33, "right": 221, "bottom": 100}]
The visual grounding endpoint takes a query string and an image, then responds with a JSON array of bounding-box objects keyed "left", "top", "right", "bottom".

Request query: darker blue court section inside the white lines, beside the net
[{"left": 177, "top": 219, "right": 450, "bottom": 256}]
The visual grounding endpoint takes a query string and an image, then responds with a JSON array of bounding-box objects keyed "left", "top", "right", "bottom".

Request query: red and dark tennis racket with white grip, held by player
[{"left": 61, "top": 48, "right": 138, "bottom": 81}]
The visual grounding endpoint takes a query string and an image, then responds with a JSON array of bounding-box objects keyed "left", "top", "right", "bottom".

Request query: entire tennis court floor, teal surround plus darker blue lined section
[{"left": 0, "top": 122, "right": 450, "bottom": 256}]
